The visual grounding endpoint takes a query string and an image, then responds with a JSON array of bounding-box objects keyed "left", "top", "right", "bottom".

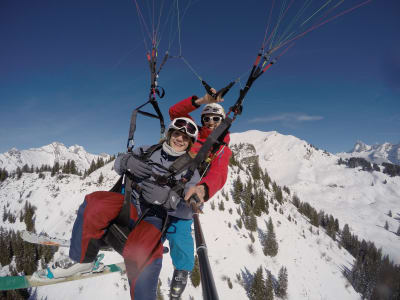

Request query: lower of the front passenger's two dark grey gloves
[{"left": 142, "top": 181, "right": 181, "bottom": 209}]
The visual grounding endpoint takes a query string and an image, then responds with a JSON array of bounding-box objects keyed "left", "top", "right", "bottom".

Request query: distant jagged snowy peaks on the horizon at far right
[{"left": 336, "top": 141, "right": 400, "bottom": 165}]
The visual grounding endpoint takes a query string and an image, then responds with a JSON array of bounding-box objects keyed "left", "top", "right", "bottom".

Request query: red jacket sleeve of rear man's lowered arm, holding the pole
[{"left": 198, "top": 146, "right": 232, "bottom": 200}]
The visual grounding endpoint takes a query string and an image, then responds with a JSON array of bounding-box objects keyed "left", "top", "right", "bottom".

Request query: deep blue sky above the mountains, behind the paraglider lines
[{"left": 0, "top": 0, "right": 400, "bottom": 153}]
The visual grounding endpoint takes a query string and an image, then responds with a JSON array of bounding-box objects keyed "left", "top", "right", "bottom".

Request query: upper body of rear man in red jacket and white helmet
[{"left": 169, "top": 89, "right": 232, "bottom": 202}]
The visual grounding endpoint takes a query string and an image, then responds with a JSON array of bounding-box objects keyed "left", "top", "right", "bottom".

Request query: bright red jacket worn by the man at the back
[{"left": 169, "top": 96, "right": 232, "bottom": 200}]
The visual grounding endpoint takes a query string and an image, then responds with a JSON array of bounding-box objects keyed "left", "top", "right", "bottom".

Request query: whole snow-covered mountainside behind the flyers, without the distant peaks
[{"left": 0, "top": 131, "right": 400, "bottom": 300}]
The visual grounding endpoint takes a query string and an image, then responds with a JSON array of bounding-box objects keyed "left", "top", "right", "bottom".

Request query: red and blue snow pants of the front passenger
[{"left": 69, "top": 192, "right": 163, "bottom": 300}]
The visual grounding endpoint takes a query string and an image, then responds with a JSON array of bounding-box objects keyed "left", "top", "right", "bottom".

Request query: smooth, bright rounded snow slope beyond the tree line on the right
[{"left": 231, "top": 130, "right": 400, "bottom": 264}]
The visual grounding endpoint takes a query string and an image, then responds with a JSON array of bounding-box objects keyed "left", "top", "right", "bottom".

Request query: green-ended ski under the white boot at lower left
[{"left": 0, "top": 262, "right": 125, "bottom": 291}]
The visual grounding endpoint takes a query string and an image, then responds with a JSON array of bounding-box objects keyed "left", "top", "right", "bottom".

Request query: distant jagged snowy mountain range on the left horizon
[{"left": 0, "top": 142, "right": 110, "bottom": 172}]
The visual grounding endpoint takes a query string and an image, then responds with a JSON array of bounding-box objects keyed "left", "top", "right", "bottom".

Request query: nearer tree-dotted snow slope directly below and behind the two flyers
[{"left": 0, "top": 132, "right": 366, "bottom": 300}]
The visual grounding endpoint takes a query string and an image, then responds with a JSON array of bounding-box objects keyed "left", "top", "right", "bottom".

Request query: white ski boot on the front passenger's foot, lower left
[{"left": 32, "top": 254, "right": 105, "bottom": 280}]
